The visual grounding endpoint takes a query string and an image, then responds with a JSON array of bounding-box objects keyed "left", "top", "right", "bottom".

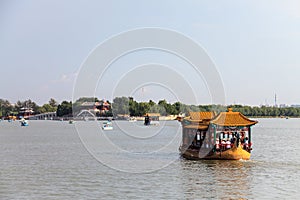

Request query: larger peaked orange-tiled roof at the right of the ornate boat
[{"left": 210, "top": 108, "right": 257, "bottom": 126}]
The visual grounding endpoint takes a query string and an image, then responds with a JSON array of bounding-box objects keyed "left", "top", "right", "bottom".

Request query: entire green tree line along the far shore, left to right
[{"left": 0, "top": 97, "right": 300, "bottom": 117}]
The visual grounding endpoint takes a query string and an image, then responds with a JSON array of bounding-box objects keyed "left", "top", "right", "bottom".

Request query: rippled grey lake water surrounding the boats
[{"left": 0, "top": 119, "right": 300, "bottom": 200}]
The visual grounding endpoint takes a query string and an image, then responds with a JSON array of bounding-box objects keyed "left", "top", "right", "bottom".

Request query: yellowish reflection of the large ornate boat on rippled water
[{"left": 180, "top": 159, "right": 254, "bottom": 199}]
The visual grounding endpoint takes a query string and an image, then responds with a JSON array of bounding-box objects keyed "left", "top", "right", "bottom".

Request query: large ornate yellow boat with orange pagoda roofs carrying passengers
[{"left": 179, "top": 108, "right": 257, "bottom": 160}]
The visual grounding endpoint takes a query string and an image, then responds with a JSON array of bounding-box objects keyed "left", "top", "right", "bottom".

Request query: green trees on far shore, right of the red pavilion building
[{"left": 112, "top": 97, "right": 300, "bottom": 117}]
